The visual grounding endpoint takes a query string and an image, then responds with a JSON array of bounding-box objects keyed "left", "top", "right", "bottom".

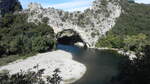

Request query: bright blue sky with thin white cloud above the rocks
[{"left": 20, "top": 0, "right": 150, "bottom": 11}]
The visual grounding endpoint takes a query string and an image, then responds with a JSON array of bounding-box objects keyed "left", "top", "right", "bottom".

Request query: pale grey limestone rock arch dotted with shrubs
[{"left": 28, "top": 0, "right": 121, "bottom": 47}]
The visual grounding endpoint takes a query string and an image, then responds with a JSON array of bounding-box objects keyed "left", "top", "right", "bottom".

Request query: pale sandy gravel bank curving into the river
[{"left": 0, "top": 50, "right": 87, "bottom": 84}]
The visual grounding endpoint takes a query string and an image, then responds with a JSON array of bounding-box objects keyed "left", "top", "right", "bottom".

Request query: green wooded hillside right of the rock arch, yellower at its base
[{"left": 96, "top": 1, "right": 150, "bottom": 51}]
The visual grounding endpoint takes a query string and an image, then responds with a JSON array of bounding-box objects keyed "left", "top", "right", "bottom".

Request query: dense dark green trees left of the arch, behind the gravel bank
[{"left": 0, "top": 14, "right": 56, "bottom": 64}]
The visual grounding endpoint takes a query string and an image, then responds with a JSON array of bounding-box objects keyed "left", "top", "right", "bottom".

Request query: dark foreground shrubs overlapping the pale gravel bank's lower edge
[{"left": 0, "top": 66, "right": 62, "bottom": 84}]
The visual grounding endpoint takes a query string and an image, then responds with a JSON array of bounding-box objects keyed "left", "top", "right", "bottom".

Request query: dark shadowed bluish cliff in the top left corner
[{"left": 0, "top": 0, "right": 22, "bottom": 17}]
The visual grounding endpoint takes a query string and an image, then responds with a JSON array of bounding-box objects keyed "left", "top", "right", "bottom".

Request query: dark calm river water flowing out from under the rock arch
[{"left": 57, "top": 44, "right": 123, "bottom": 84}]
